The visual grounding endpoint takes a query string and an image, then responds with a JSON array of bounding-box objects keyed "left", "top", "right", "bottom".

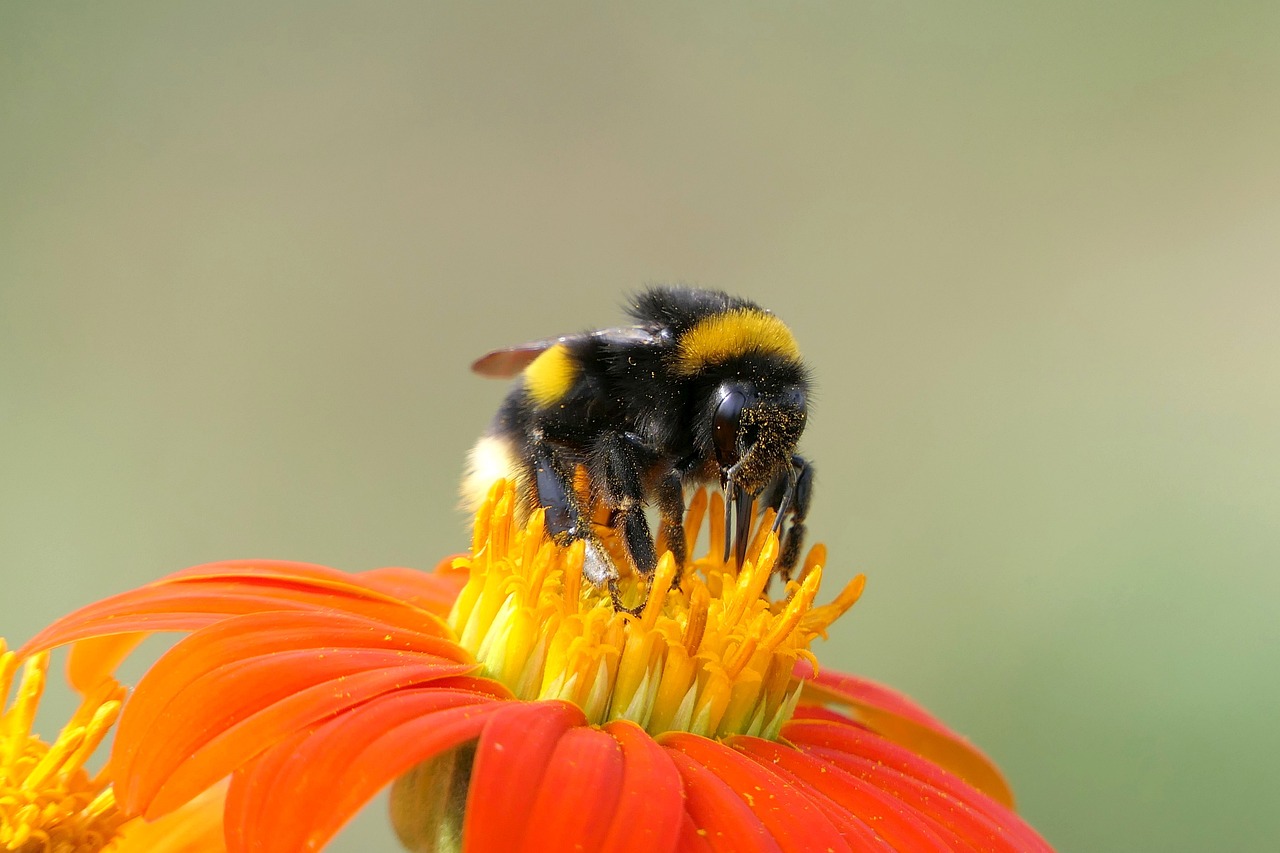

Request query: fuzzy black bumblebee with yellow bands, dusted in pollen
[{"left": 462, "top": 287, "right": 813, "bottom": 610}]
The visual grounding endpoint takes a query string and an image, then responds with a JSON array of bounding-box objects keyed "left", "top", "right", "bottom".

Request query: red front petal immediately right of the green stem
[{"left": 462, "top": 702, "right": 586, "bottom": 853}]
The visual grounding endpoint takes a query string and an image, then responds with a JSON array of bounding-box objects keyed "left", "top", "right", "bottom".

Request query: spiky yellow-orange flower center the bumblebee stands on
[{"left": 449, "top": 482, "right": 863, "bottom": 738}]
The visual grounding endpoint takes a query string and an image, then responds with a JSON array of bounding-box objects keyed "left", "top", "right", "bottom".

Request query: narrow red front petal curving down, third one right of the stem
[{"left": 600, "top": 720, "right": 686, "bottom": 853}]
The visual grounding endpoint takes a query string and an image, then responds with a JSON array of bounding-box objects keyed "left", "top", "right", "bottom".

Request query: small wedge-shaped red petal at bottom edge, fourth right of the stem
[{"left": 668, "top": 749, "right": 782, "bottom": 853}]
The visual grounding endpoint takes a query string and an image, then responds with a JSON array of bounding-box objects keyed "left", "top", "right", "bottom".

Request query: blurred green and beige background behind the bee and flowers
[{"left": 0, "top": 0, "right": 1280, "bottom": 850}]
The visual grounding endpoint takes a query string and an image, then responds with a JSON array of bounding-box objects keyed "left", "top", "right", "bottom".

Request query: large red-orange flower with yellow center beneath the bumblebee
[{"left": 26, "top": 484, "right": 1050, "bottom": 853}]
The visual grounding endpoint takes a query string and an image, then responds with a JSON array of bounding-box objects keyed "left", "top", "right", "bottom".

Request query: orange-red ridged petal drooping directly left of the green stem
[{"left": 227, "top": 685, "right": 507, "bottom": 853}]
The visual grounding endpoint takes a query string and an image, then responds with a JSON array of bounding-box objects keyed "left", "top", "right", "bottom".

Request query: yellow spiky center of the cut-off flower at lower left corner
[{"left": 0, "top": 639, "right": 124, "bottom": 853}]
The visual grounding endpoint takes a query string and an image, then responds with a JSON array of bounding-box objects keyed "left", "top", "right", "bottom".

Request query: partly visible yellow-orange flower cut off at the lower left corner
[{"left": 0, "top": 639, "right": 225, "bottom": 853}]
